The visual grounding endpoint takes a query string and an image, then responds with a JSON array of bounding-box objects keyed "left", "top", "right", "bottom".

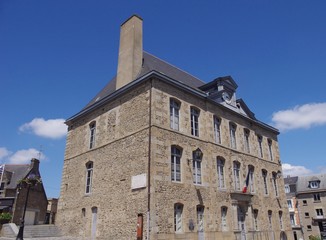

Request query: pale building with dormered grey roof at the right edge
[{"left": 296, "top": 174, "right": 326, "bottom": 240}]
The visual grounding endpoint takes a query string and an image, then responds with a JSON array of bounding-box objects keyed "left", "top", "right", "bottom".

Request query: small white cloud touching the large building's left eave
[{"left": 19, "top": 118, "right": 67, "bottom": 139}]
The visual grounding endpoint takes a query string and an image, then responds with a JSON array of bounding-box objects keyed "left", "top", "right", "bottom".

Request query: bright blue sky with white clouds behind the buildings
[{"left": 0, "top": 0, "right": 326, "bottom": 197}]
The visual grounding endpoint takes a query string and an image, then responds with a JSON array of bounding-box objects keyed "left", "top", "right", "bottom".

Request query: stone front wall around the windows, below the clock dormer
[{"left": 151, "top": 78, "right": 292, "bottom": 239}]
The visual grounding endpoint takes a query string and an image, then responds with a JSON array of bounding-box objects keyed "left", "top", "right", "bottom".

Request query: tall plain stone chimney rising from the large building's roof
[{"left": 116, "top": 15, "right": 143, "bottom": 89}]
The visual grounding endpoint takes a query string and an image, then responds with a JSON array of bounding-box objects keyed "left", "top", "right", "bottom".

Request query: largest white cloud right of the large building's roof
[{"left": 272, "top": 103, "right": 326, "bottom": 131}]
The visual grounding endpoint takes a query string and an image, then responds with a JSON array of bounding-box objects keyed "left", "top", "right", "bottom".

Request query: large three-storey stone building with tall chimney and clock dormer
[{"left": 56, "top": 16, "right": 292, "bottom": 240}]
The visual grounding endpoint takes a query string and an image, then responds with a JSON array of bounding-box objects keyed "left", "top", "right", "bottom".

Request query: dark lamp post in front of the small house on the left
[{"left": 16, "top": 169, "right": 41, "bottom": 240}]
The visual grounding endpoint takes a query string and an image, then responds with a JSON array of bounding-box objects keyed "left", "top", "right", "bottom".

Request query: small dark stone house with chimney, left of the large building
[{"left": 0, "top": 158, "right": 48, "bottom": 225}]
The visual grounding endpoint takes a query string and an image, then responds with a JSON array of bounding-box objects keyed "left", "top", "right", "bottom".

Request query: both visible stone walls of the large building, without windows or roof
[{"left": 57, "top": 77, "right": 292, "bottom": 240}]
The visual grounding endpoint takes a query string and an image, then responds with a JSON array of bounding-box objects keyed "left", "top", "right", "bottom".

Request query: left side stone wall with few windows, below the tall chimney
[{"left": 57, "top": 82, "right": 149, "bottom": 240}]
